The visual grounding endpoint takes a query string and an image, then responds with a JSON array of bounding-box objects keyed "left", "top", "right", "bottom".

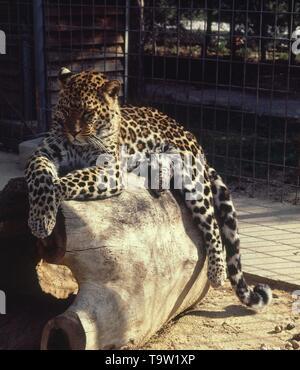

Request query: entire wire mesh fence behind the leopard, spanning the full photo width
[{"left": 0, "top": 0, "right": 300, "bottom": 202}]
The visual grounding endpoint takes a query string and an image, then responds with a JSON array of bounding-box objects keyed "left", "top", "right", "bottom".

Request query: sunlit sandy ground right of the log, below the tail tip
[{"left": 145, "top": 286, "right": 300, "bottom": 350}]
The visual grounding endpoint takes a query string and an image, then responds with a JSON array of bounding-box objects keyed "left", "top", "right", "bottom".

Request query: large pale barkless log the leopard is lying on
[{"left": 0, "top": 176, "right": 209, "bottom": 350}]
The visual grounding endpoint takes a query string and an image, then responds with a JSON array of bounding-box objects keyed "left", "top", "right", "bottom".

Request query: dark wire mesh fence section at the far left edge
[{"left": 0, "top": 0, "right": 37, "bottom": 149}]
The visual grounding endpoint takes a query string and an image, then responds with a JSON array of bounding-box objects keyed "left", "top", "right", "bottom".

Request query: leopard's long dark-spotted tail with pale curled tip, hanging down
[{"left": 208, "top": 168, "right": 272, "bottom": 310}]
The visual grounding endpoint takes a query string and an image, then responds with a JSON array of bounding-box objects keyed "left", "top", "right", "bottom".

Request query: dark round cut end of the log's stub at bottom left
[{"left": 41, "top": 312, "right": 86, "bottom": 351}]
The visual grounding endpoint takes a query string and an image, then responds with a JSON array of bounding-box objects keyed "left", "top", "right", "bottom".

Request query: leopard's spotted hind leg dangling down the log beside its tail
[{"left": 152, "top": 148, "right": 226, "bottom": 288}]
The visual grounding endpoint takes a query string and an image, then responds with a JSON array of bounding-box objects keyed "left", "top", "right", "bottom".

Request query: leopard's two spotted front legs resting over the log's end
[{"left": 25, "top": 147, "right": 121, "bottom": 239}]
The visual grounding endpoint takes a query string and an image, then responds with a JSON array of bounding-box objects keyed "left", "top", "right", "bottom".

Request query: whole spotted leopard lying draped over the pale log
[{"left": 25, "top": 67, "right": 272, "bottom": 310}]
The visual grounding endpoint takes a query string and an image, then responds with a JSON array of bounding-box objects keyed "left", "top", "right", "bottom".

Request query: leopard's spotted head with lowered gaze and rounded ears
[{"left": 56, "top": 68, "right": 121, "bottom": 148}]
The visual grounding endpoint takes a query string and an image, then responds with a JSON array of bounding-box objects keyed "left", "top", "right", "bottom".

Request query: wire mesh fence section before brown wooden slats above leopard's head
[{"left": 45, "top": 0, "right": 127, "bottom": 119}]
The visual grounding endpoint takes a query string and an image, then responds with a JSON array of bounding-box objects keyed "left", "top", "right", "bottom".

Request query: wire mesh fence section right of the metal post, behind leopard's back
[{"left": 129, "top": 0, "right": 300, "bottom": 202}]
